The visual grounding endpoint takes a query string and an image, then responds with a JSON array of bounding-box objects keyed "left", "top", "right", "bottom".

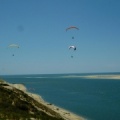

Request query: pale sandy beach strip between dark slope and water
[{"left": 8, "top": 83, "right": 86, "bottom": 120}]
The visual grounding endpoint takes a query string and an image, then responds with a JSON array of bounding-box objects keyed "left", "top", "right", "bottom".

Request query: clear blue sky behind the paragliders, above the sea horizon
[{"left": 0, "top": 0, "right": 120, "bottom": 75}]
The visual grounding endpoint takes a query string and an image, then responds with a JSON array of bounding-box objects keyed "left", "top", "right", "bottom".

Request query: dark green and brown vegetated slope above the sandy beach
[{"left": 0, "top": 82, "right": 64, "bottom": 120}]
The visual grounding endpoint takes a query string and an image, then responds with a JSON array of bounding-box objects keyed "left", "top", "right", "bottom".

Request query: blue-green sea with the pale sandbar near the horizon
[{"left": 0, "top": 73, "right": 120, "bottom": 120}]
